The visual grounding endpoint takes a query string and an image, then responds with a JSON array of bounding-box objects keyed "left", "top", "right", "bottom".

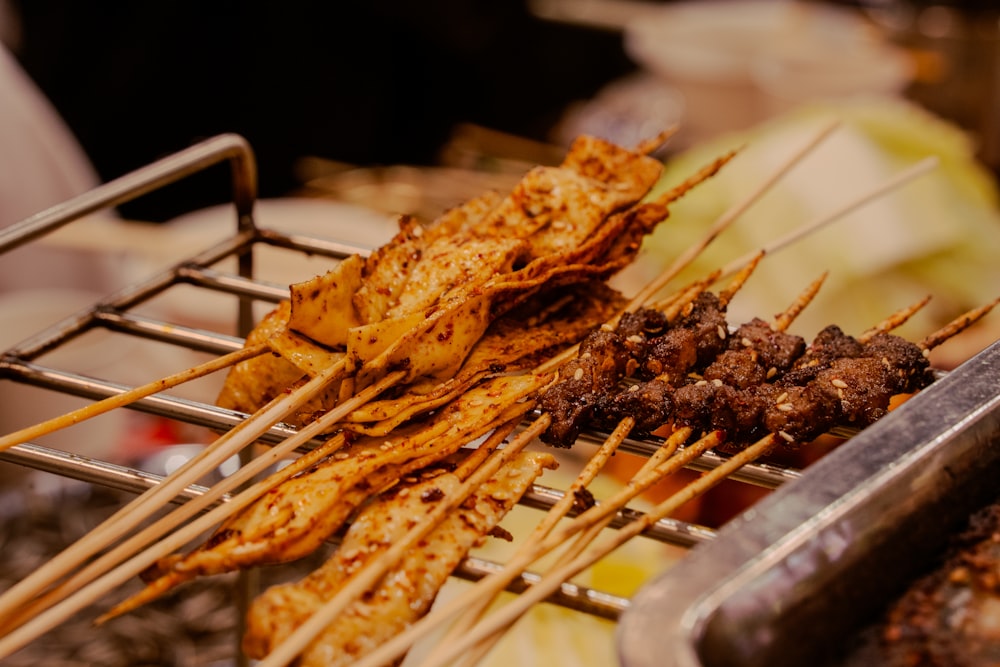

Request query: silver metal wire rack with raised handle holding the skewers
[{"left": 0, "top": 134, "right": 824, "bottom": 664}]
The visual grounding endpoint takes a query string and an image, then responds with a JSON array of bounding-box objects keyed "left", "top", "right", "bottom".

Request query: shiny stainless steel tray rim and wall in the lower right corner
[{"left": 617, "top": 342, "right": 1000, "bottom": 667}]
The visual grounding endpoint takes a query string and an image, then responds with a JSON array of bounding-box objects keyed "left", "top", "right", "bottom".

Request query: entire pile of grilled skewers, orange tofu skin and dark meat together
[{"left": 0, "top": 121, "right": 986, "bottom": 664}]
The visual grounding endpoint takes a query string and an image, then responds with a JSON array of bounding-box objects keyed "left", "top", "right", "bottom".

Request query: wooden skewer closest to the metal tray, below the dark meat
[{"left": 410, "top": 435, "right": 775, "bottom": 667}]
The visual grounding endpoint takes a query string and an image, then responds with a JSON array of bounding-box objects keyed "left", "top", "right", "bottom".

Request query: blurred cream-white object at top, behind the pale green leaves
[{"left": 624, "top": 0, "right": 911, "bottom": 142}]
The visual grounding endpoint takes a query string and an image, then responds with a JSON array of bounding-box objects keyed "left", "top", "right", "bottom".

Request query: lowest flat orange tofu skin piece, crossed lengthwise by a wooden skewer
[{"left": 243, "top": 452, "right": 556, "bottom": 667}]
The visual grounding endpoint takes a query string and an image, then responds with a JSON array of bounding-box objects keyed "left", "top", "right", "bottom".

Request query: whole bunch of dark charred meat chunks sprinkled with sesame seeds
[{"left": 541, "top": 274, "right": 948, "bottom": 448}]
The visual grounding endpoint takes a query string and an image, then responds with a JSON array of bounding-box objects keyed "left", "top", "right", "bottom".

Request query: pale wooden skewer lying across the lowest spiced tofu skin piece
[{"left": 250, "top": 415, "right": 549, "bottom": 667}]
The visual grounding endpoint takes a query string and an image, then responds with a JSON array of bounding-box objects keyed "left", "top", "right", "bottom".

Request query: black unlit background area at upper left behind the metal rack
[{"left": 14, "top": 0, "right": 635, "bottom": 220}]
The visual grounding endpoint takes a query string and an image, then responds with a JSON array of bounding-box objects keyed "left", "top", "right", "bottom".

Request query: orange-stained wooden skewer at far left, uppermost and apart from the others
[{"left": 0, "top": 345, "right": 268, "bottom": 451}]
